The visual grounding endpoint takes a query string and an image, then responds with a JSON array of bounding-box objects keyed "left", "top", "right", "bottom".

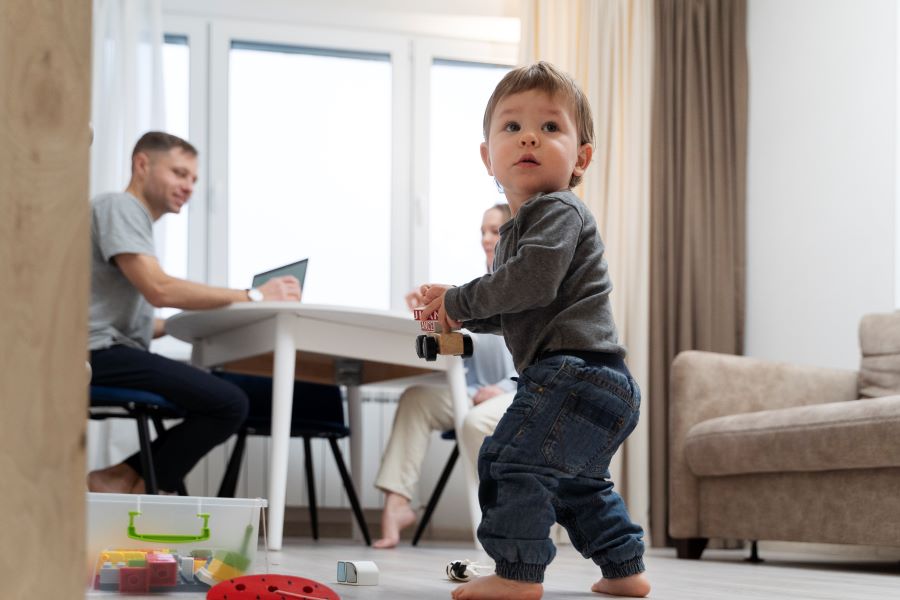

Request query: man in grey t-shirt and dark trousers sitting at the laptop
[{"left": 88, "top": 132, "right": 300, "bottom": 493}]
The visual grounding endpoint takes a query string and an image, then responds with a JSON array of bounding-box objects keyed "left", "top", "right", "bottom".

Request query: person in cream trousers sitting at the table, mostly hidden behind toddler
[{"left": 373, "top": 204, "right": 516, "bottom": 548}]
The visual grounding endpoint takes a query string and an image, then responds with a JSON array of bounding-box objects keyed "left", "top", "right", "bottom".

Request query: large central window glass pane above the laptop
[{"left": 228, "top": 42, "right": 392, "bottom": 309}]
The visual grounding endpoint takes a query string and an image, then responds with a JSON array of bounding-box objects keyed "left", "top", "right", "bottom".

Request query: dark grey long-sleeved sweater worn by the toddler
[{"left": 444, "top": 190, "right": 625, "bottom": 373}]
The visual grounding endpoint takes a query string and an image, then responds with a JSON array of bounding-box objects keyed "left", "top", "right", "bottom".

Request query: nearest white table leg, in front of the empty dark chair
[{"left": 268, "top": 314, "right": 297, "bottom": 550}]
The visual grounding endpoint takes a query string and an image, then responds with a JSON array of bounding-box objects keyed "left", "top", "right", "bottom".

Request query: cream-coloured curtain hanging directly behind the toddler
[{"left": 520, "top": 0, "right": 653, "bottom": 544}]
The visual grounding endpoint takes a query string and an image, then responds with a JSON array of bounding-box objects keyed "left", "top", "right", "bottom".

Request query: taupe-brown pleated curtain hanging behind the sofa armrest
[{"left": 649, "top": 0, "right": 747, "bottom": 545}]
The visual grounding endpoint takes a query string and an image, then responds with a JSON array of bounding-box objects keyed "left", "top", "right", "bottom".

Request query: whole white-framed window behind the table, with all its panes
[{"left": 166, "top": 16, "right": 518, "bottom": 310}]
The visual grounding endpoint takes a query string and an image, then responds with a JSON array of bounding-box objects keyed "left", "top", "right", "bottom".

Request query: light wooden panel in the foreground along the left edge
[{"left": 0, "top": 0, "right": 91, "bottom": 599}]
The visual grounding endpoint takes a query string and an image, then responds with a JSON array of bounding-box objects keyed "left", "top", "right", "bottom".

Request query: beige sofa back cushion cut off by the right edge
[{"left": 859, "top": 312, "right": 900, "bottom": 398}]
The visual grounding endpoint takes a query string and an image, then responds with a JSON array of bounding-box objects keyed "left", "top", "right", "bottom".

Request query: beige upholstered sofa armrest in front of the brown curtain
[{"left": 669, "top": 351, "right": 858, "bottom": 539}]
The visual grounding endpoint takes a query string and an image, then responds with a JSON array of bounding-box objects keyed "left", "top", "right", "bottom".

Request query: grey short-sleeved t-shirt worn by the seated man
[{"left": 89, "top": 192, "right": 155, "bottom": 350}]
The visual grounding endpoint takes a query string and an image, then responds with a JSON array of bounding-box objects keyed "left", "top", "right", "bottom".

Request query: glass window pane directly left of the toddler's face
[{"left": 428, "top": 60, "right": 509, "bottom": 284}]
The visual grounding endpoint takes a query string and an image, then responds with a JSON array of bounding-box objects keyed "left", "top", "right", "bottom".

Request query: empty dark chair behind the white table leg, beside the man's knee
[{"left": 215, "top": 371, "right": 372, "bottom": 545}]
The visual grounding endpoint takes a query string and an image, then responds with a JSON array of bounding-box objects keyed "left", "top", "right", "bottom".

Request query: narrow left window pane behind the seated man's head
[{"left": 155, "top": 36, "right": 190, "bottom": 286}]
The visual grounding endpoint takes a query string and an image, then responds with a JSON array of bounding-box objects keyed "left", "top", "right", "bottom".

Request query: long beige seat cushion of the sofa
[{"left": 685, "top": 396, "right": 900, "bottom": 476}]
